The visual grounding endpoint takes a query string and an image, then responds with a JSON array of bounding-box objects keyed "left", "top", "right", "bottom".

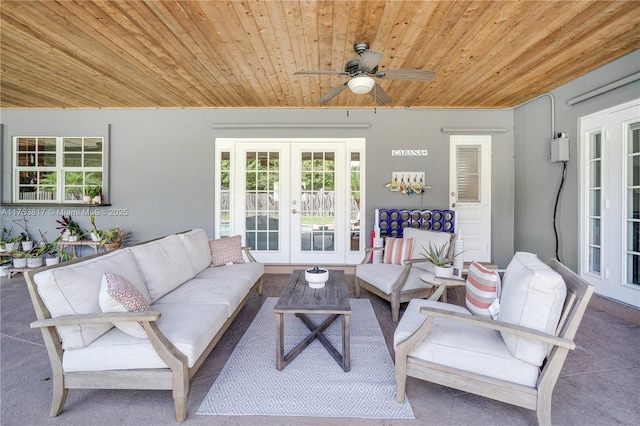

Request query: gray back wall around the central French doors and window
[{"left": 1, "top": 109, "right": 514, "bottom": 266}]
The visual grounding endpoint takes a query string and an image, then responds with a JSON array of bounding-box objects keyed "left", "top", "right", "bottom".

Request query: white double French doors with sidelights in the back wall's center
[{"left": 216, "top": 139, "right": 364, "bottom": 265}]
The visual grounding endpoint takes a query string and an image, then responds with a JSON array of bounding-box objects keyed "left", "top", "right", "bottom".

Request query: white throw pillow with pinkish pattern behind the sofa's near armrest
[{"left": 99, "top": 272, "right": 151, "bottom": 339}]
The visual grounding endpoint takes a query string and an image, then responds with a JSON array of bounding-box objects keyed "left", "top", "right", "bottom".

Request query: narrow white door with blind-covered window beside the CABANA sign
[{"left": 449, "top": 135, "right": 491, "bottom": 262}]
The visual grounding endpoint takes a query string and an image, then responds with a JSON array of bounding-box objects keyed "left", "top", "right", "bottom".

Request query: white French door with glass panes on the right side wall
[{"left": 579, "top": 101, "right": 640, "bottom": 307}]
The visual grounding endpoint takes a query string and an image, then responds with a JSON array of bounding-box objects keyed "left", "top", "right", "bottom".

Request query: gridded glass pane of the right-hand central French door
[{"left": 299, "top": 151, "right": 336, "bottom": 252}]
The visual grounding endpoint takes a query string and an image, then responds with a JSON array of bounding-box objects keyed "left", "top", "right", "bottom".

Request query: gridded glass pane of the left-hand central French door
[{"left": 245, "top": 151, "right": 280, "bottom": 251}]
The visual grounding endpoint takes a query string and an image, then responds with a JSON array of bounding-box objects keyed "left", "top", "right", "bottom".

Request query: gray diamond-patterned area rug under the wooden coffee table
[{"left": 198, "top": 297, "right": 415, "bottom": 419}]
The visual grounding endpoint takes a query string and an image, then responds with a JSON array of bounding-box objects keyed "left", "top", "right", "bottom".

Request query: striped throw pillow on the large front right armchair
[{"left": 465, "top": 262, "right": 500, "bottom": 318}]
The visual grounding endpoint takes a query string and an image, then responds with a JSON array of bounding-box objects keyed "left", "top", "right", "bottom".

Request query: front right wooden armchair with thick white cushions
[{"left": 394, "top": 253, "right": 593, "bottom": 425}]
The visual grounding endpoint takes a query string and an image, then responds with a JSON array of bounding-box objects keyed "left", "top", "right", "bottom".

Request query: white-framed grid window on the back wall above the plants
[{"left": 13, "top": 136, "right": 106, "bottom": 203}]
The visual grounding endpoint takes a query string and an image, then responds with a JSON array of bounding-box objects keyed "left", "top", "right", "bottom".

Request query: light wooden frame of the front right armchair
[{"left": 395, "top": 259, "right": 594, "bottom": 425}]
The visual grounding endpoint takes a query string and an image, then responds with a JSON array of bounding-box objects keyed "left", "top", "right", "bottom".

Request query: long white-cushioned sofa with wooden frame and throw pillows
[{"left": 26, "top": 229, "right": 264, "bottom": 421}]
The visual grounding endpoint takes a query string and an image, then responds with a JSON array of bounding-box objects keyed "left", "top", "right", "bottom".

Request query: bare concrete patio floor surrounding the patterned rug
[{"left": 0, "top": 273, "right": 640, "bottom": 426}]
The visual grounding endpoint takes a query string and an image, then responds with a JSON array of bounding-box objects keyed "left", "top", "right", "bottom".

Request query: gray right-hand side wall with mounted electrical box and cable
[{"left": 514, "top": 51, "right": 640, "bottom": 271}]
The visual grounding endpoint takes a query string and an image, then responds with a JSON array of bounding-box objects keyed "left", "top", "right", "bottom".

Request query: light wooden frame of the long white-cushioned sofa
[{"left": 24, "top": 243, "right": 264, "bottom": 422}]
